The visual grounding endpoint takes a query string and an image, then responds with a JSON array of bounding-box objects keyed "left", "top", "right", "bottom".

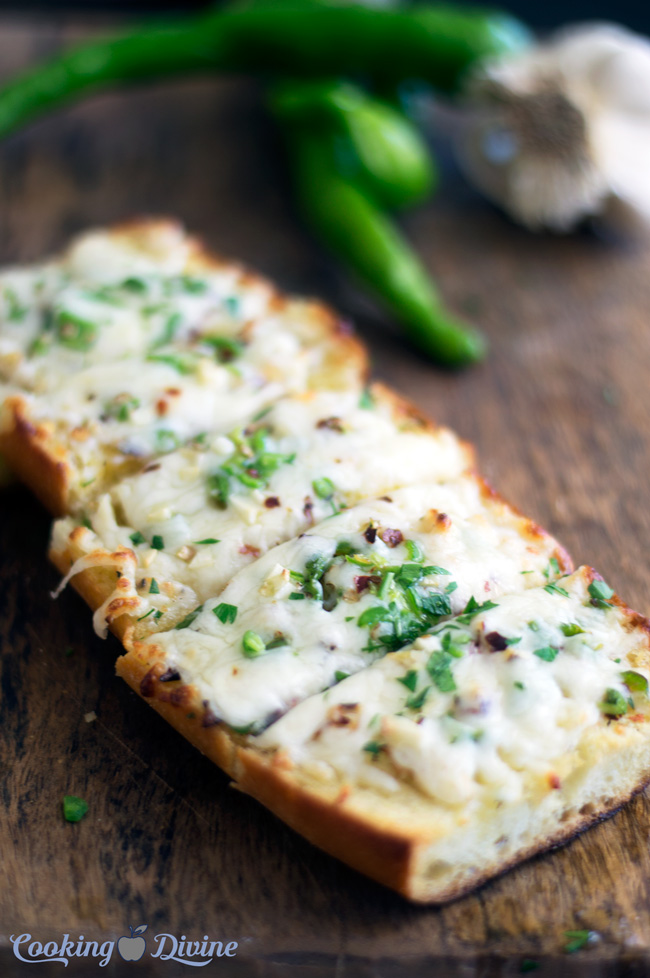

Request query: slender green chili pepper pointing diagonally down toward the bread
[{"left": 290, "top": 130, "right": 486, "bottom": 367}]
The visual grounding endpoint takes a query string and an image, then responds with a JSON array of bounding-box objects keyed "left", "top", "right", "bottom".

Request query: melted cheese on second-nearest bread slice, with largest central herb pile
[{"left": 135, "top": 478, "right": 555, "bottom": 729}]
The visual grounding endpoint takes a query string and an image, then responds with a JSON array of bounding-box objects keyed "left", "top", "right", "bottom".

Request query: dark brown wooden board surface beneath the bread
[{"left": 0, "top": 15, "right": 650, "bottom": 978}]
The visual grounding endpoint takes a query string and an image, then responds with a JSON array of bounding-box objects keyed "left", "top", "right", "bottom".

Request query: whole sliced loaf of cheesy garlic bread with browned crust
[{"left": 0, "top": 221, "right": 650, "bottom": 902}]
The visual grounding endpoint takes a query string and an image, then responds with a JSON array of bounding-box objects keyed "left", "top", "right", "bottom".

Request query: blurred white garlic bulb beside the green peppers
[{"left": 457, "top": 24, "right": 650, "bottom": 231}]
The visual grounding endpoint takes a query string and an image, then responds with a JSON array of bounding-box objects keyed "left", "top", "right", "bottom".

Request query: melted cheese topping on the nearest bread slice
[{"left": 256, "top": 568, "right": 650, "bottom": 812}]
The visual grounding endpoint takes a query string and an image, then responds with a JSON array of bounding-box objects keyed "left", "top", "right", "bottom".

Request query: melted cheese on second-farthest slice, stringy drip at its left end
[{"left": 54, "top": 390, "right": 470, "bottom": 600}]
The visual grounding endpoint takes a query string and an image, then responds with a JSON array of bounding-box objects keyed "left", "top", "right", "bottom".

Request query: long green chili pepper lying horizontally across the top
[{"left": 0, "top": 0, "right": 528, "bottom": 136}]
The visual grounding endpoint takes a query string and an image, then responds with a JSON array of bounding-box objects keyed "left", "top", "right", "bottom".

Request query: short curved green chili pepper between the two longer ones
[{"left": 271, "top": 81, "right": 437, "bottom": 209}]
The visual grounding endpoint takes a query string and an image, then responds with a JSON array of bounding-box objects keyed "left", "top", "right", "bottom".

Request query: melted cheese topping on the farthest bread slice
[{"left": 0, "top": 229, "right": 361, "bottom": 509}]
